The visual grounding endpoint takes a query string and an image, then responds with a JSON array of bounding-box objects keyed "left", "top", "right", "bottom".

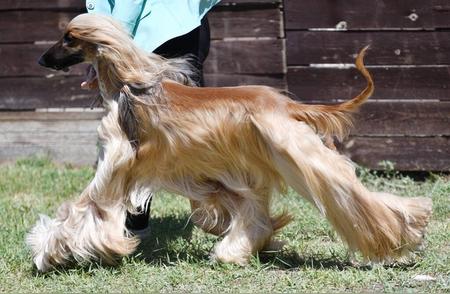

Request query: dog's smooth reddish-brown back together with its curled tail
[{"left": 162, "top": 47, "right": 374, "bottom": 144}]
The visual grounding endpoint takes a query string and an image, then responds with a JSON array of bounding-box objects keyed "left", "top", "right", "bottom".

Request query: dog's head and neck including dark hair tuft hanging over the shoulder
[{"left": 39, "top": 14, "right": 200, "bottom": 149}]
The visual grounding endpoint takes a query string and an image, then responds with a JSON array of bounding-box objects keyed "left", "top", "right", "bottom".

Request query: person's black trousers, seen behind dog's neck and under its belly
[{"left": 126, "top": 17, "right": 210, "bottom": 230}]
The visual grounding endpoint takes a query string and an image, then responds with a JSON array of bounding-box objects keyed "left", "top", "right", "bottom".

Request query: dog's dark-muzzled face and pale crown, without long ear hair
[{"left": 38, "top": 14, "right": 132, "bottom": 70}]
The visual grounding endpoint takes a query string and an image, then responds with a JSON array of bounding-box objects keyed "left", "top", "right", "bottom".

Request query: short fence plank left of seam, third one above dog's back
[{"left": 208, "top": 7, "right": 283, "bottom": 39}]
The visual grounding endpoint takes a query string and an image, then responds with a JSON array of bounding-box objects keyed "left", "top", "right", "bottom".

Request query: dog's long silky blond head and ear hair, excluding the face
[{"left": 67, "top": 14, "right": 196, "bottom": 89}]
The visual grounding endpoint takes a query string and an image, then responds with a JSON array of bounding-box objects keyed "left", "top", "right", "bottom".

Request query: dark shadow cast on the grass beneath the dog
[{"left": 32, "top": 216, "right": 416, "bottom": 277}]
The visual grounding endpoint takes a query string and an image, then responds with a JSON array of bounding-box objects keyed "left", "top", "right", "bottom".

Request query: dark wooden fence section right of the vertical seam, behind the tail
[{"left": 284, "top": 0, "right": 450, "bottom": 170}]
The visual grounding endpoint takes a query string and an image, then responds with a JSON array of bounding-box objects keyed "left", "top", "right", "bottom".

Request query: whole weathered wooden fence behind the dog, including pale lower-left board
[{"left": 0, "top": 0, "right": 450, "bottom": 171}]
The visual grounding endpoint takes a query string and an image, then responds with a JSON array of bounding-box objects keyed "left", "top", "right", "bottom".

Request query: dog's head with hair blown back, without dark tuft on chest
[{"left": 39, "top": 14, "right": 198, "bottom": 90}]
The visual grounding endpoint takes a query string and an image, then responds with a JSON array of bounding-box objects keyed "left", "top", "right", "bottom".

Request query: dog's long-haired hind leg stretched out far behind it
[{"left": 255, "top": 115, "right": 431, "bottom": 261}]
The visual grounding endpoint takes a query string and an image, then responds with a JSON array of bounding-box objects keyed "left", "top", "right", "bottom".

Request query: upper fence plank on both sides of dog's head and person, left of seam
[{"left": 0, "top": 6, "right": 282, "bottom": 43}]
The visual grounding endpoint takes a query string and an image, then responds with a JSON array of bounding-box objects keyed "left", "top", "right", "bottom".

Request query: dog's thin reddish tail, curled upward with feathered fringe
[{"left": 288, "top": 46, "right": 374, "bottom": 140}]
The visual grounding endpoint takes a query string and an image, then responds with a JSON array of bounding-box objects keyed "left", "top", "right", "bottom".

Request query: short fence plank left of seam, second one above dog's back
[{"left": 204, "top": 40, "right": 285, "bottom": 74}]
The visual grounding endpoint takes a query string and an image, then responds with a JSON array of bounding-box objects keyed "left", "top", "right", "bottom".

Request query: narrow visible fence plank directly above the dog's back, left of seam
[{"left": 205, "top": 73, "right": 287, "bottom": 89}]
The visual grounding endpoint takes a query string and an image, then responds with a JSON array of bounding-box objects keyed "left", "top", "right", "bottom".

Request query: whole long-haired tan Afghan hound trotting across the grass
[{"left": 27, "top": 14, "right": 431, "bottom": 271}]
